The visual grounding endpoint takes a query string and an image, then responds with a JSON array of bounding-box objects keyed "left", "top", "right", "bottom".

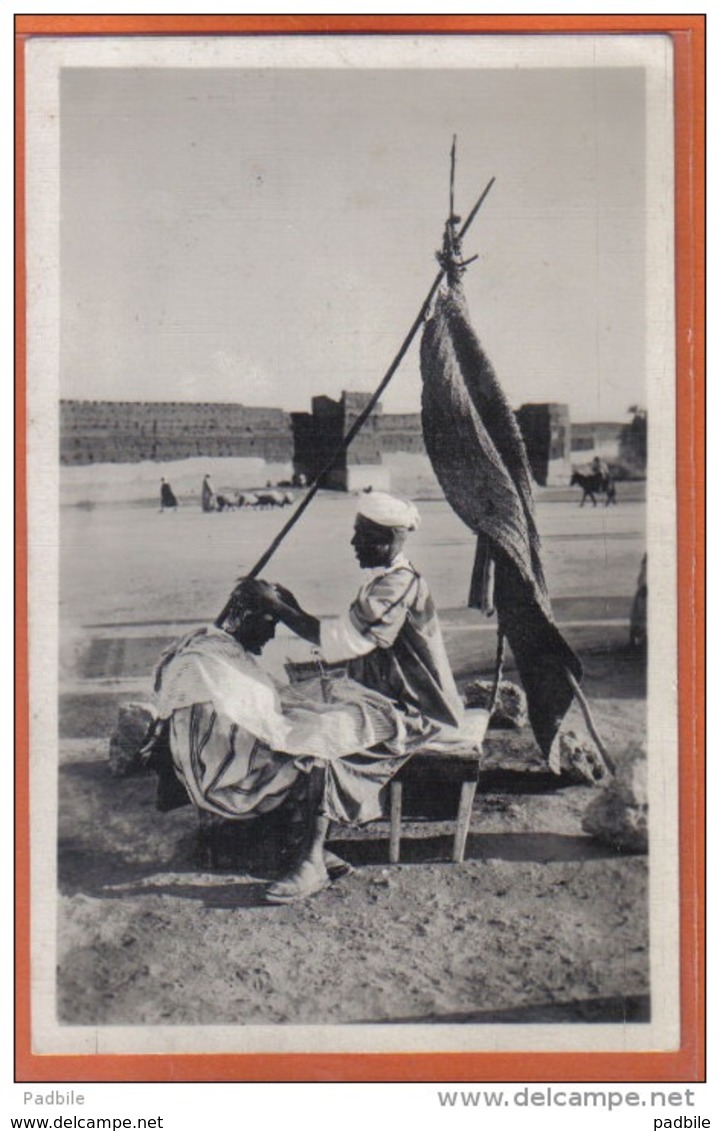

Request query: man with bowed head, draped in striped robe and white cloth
[{"left": 149, "top": 581, "right": 408, "bottom": 903}]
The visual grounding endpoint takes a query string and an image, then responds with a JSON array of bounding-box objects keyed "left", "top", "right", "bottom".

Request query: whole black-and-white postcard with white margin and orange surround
[{"left": 18, "top": 17, "right": 703, "bottom": 1080}]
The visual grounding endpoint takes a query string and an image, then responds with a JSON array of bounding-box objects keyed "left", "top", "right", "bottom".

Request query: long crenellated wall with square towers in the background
[{"left": 60, "top": 391, "right": 647, "bottom": 491}]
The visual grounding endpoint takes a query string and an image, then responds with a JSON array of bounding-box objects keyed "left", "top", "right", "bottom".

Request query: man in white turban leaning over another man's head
[{"left": 258, "top": 491, "right": 463, "bottom": 749}]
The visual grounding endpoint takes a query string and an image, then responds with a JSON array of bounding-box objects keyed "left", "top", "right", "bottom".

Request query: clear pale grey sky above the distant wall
[{"left": 60, "top": 40, "right": 648, "bottom": 421}]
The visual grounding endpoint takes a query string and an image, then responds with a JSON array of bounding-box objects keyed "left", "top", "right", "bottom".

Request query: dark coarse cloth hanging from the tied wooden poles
[{"left": 420, "top": 279, "right": 582, "bottom": 757}]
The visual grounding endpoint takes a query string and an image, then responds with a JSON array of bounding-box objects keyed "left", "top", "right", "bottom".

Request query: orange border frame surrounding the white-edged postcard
[{"left": 15, "top": 15, "right": 705, "bottom": 1082}]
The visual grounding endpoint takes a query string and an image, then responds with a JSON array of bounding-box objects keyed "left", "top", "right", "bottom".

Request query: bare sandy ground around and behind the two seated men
[{"left": 58, "top": 477, "right": 650, "bottom": 1026}]
